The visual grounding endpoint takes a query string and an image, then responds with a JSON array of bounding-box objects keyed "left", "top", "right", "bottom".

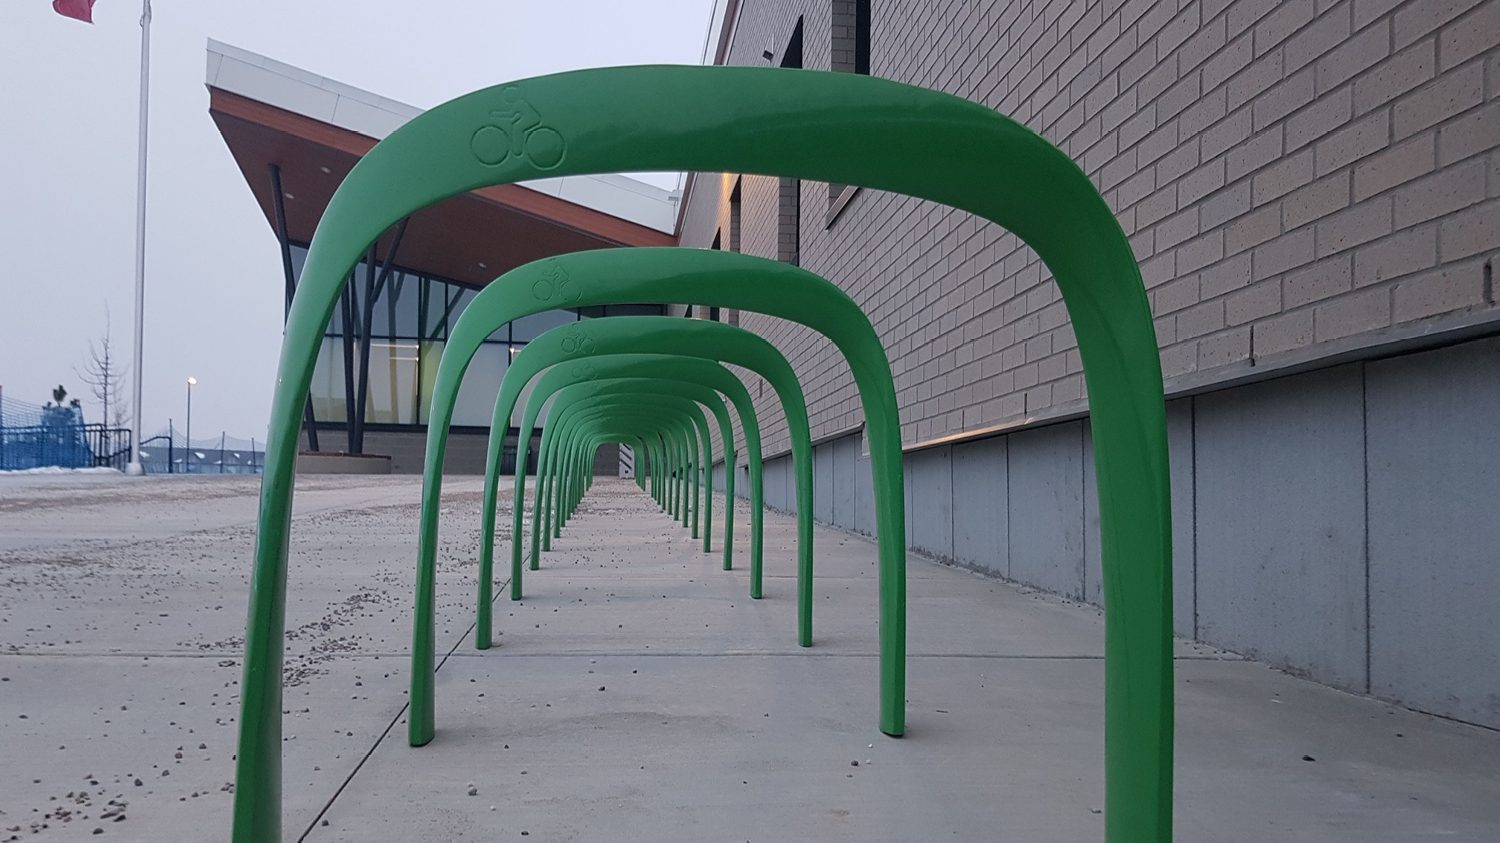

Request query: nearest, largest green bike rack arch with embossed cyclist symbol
[{"left": 234, "top": 66, "right": 1172, "bottom": 840}]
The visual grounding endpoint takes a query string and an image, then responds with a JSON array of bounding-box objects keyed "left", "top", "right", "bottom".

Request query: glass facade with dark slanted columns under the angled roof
[{"left": 291, "top": 245, "right": 663, "bottom": 428}]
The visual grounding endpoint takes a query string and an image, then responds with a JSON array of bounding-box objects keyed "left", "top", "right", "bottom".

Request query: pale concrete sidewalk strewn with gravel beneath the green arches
[{"left": 0, "top": 477, "right": 1500, "bottom": 842}]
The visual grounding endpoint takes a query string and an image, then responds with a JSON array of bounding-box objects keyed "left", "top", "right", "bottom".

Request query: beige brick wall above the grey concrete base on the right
[{"left": 683, "top": 0, "right": 1500, "bottom": 453}]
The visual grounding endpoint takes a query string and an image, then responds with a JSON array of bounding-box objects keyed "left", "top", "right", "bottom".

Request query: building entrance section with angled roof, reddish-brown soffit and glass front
[{"left": 207, "top": 41, "right": 677, "bottom": 473}]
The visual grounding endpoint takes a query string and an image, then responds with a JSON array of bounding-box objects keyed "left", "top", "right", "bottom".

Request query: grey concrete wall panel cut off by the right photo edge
[{"left": 1367, "top": 339, "right": 1500, "bottom": 728}]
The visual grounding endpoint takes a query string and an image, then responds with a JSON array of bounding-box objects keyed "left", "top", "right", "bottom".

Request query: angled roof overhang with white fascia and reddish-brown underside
[{"left": 209, "top": 42, "right": 677, "bottom": 287}]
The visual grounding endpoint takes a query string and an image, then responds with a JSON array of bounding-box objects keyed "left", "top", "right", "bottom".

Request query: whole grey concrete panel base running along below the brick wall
[{"left": 729, "top": 339, "right": 1500, "bottom": 726}]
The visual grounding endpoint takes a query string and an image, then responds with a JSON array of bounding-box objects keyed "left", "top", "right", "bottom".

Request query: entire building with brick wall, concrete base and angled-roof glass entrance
[{"left": 210, "top": 0, "right": 1500, "bottom": 728}]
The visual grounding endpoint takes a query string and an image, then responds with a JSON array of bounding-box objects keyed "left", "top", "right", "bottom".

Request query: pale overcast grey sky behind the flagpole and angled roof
[{"left": 0, "top": 0, "right": 713, "bottom": 440}]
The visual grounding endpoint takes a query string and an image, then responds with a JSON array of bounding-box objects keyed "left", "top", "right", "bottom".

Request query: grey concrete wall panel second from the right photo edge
[{"left": 1196, "top": 365, "right": 1367, "bottom": 690}]
